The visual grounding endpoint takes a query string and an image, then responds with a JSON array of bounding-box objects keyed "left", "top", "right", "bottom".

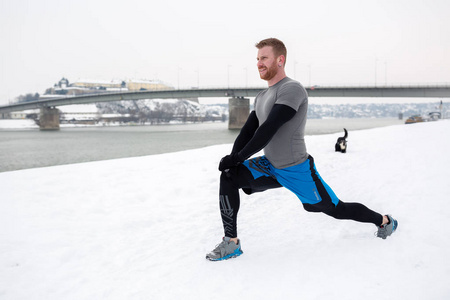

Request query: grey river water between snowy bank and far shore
[{"left": 0, "top": 118, "right": 403, "bottom": 172}]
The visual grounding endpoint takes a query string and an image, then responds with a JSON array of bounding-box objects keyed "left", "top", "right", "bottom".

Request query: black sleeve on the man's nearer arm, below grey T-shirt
[{"left": 238, "top": 104, "right": 297, "bottom": 161}]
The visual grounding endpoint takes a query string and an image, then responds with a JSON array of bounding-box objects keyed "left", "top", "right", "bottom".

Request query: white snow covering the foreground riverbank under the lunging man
[{"left": 0, "top": 120, "right": 450, "bottom": 299}]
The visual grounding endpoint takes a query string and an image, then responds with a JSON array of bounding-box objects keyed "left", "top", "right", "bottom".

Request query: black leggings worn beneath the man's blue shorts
[{"left": 219, "top": 164, "right": 383, "bottom": 238}]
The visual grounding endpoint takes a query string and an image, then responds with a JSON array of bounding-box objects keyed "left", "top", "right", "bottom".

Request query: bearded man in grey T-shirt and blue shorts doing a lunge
[{"left": 206, "top": 38, "right": 398, "bottom": 261}]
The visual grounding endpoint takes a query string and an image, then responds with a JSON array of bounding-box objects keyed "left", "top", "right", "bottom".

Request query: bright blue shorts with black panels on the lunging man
[{"left": 243, "top": 156, "right": 339, "bottom": 209}]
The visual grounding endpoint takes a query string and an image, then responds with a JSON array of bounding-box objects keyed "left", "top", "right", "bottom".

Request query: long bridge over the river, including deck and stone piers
[{"left": 0, "top": 85, "right": 450, "bottom": 130}]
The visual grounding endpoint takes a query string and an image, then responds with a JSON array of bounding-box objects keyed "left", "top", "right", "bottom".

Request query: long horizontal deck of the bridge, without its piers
[{"left": 0, "top": 84, "right": 450, "bottom": 113}]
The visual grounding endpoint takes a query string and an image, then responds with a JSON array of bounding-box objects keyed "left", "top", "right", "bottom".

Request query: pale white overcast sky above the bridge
[{"left": 0, "top": 0, "right": 450, "bottom": 105}]
